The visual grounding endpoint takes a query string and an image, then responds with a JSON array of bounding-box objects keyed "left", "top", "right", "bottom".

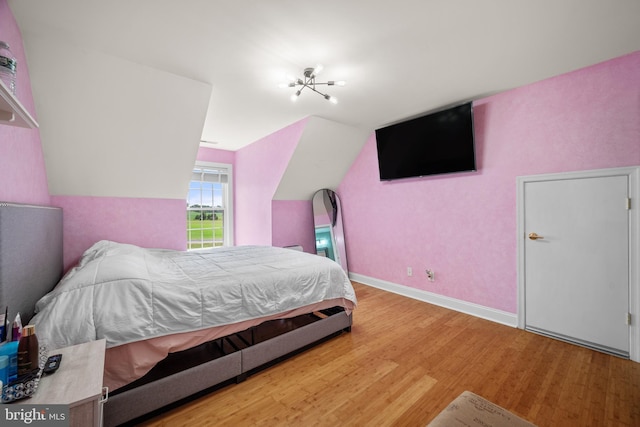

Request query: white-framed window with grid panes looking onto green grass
[{"left": 187, "top": 162, "right": 233, "bottom": 249}]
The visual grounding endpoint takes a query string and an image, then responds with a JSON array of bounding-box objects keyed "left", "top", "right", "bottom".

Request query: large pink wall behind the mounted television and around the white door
[{"left": 338, "top": 52, "right": 640, "bottom": 313}]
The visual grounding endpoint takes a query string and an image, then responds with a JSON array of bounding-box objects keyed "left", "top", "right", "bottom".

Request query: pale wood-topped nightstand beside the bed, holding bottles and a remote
[{"left": 16, "top": 340, "right": 106, "bottom": 427}]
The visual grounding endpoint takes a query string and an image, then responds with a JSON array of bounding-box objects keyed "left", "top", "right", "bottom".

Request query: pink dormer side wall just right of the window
[{"left": 235, "top": 119, "right": 307, "bottom": 245}]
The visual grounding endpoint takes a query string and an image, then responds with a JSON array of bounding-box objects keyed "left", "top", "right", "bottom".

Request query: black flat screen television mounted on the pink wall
[{"left": 376, "top": 102, "right": 476, "bottom": 181}]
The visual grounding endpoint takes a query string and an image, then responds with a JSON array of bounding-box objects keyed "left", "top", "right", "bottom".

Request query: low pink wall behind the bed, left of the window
[{"left": 51, "top": 196, "right": 187, "bottom": 271}]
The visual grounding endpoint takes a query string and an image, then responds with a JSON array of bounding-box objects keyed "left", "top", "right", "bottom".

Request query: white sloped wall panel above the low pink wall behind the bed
[{"left": 24, "top": 34, "right": 211, "bottom": 198}]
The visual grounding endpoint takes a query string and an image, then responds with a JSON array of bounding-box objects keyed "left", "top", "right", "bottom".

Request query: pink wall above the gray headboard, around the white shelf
[{"left": 0, "top": 0, "right": 50, "bottom": 205}]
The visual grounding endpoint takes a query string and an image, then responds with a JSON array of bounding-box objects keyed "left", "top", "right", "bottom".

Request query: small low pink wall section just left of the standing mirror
[{"left": 271, "top": 200, "right": 316, "bottom": 253}]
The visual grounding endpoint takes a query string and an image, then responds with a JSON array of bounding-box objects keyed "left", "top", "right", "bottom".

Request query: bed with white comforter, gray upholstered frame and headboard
[{"left": 0, "top": 204, "right": 356, "bottom": 426}]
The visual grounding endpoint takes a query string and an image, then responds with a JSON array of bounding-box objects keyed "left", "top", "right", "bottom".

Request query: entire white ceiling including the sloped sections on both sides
[{"left": 6, "top": 0, "right": 640, "bottom": 200}]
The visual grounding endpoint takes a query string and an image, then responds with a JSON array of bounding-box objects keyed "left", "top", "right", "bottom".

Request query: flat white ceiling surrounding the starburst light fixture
[{"left": 8, "top": 0, "right": 640, "bottom": 150}]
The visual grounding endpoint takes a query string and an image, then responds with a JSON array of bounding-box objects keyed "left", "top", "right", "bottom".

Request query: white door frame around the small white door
[{"left": 516, "top": 166, "right": 640, "bottom": 362}]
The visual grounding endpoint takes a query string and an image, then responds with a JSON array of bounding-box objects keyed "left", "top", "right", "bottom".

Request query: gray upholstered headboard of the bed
[{"left": 0, "top": 202, "right": 62, "bottom": 325}]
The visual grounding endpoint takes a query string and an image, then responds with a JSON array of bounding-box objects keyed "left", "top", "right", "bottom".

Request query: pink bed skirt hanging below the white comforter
[{"left": 104, "top": 298, "right": 354, "bottom": 391}]
